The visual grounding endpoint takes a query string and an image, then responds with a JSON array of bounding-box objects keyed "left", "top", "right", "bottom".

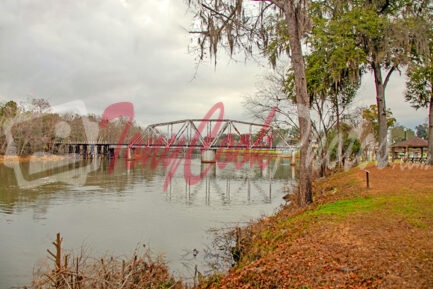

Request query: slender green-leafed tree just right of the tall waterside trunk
[{"left": 307, "top": 1, "right": 364, "bottom": 167}]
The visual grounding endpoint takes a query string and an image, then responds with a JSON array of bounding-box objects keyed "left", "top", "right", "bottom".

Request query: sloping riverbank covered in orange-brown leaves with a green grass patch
[{"left": 197, "top": 164, "right": 433, "bottom": 288}]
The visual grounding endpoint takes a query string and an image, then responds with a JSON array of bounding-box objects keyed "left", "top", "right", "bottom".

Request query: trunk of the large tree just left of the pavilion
[{"left": 372, "top": 63, "right": 388, "bottom": 168}]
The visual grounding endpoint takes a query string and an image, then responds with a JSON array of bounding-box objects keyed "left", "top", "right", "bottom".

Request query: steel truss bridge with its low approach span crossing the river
[{"left": 55, "top": 119, "right": 293, "bottom": 155}]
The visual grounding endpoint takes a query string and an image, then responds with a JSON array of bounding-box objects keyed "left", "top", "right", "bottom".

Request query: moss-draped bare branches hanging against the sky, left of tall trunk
[{"left": 186, "top": 0, "right": 282, "bottom": 64}]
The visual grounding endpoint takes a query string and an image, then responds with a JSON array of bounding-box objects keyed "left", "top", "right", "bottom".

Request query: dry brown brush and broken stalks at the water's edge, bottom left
[{"left": 31, "top": 235, "right": 184, "bottom": 289}]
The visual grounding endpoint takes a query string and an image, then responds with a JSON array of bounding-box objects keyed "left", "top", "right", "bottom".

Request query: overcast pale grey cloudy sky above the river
[{"left": 0, "top": 0, "right": 427, "bottom": 128}]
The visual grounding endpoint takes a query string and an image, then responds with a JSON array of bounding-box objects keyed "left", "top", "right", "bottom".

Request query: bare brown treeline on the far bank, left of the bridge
[{"left": 0, "top": 99, "right": 142, "bottom": 155}]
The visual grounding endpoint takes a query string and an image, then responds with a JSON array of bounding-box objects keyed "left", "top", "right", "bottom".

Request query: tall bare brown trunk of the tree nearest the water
[{"left": 284, "top": 0, "right": 313, "bottom": 207}]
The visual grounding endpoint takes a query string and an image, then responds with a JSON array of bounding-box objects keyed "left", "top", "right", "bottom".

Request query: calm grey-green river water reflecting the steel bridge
[{"left": 0, "top": 154, "right": 296, "bottom": 288}]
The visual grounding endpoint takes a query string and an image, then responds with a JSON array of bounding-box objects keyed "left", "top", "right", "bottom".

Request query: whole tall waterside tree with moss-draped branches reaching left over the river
[{"left": 188, "top": 0, "right": 313, "bottom": 206}]
